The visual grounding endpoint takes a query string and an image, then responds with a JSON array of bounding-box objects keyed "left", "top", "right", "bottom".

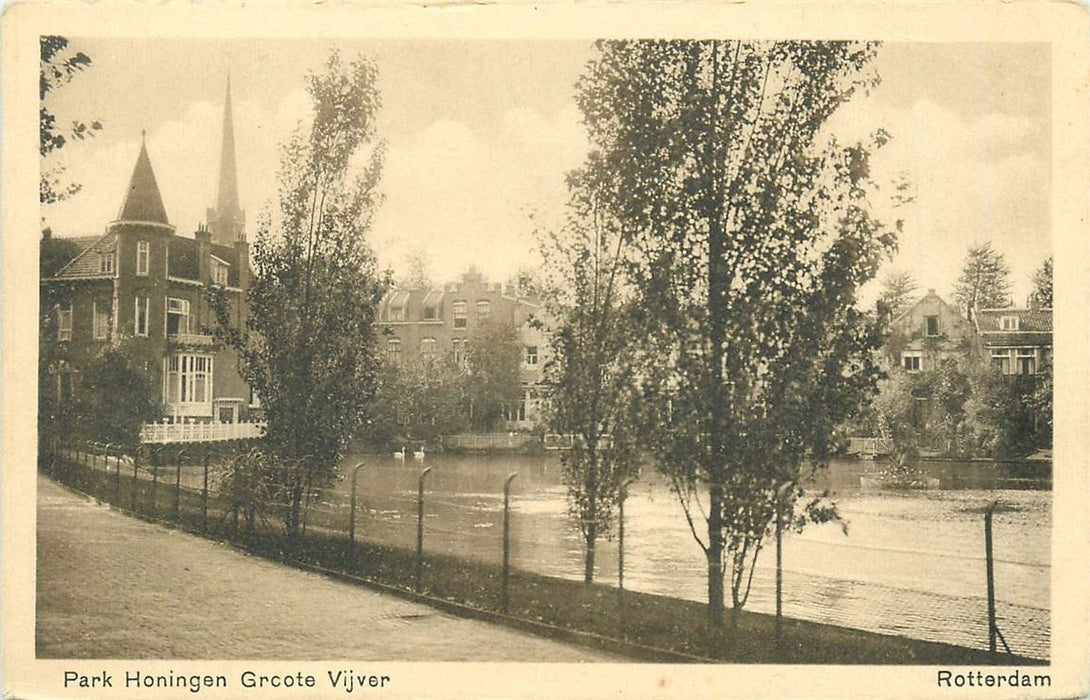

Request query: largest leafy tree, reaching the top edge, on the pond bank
[{"left": 578, "top": 40, "right": 896, "bottom": 628}]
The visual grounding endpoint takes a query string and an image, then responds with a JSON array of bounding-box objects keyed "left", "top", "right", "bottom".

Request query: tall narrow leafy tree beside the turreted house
[{"left": 213, "top": 52, "right": 388, "bottom": 534}]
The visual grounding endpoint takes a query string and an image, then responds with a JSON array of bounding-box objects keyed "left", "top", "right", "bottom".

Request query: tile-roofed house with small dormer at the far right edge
[{"left": 973, "top": 307, "right": 1052, "bottom": 375}]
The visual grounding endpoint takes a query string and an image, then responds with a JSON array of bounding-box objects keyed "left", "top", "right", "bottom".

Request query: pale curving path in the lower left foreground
[{"left": 36, "top": 475, "right": 625, "bottom": 662}]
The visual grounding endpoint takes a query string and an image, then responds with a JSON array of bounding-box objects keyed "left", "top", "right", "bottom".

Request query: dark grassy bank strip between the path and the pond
[{"left": 46, "top": 464, "right": 1047, "bottom": 665}]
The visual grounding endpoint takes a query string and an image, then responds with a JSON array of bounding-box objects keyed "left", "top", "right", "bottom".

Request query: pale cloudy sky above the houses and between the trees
[{"left": 43, "top": 37, "right": 1052, "bottom": 302}]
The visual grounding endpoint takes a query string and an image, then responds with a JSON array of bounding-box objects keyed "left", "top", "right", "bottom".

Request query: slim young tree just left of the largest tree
[{"left": 542, "top": 204, "right": 641, "bottom": 583}]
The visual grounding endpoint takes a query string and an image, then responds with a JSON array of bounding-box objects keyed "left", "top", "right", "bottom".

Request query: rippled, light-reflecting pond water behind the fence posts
[{"left": 320, "top": 454, "right": 1052, "bottom": 657}]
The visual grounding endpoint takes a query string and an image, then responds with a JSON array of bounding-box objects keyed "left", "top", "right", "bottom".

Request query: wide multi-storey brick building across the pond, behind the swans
[{"left": 378, "top": 270, "right": 547, "bottom": 430}]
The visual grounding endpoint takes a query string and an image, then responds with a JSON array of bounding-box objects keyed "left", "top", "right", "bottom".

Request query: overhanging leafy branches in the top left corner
[{"left": 38, "top": 36, "right": 102, "bottom": 204}]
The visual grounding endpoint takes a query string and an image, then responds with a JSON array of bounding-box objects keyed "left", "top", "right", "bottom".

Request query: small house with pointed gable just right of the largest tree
[{"left": 886, "top": 289, "right": 973, "bottom": 373}]
